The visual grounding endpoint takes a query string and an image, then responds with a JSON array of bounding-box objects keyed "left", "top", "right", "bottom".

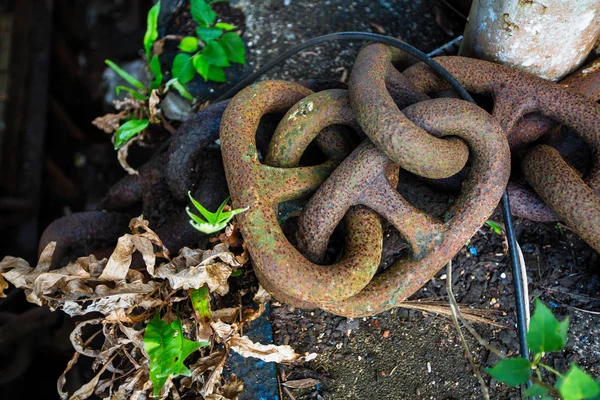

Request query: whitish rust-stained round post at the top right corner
[{"left": 461, "top": 0, "right": 600, "bottom": 80}]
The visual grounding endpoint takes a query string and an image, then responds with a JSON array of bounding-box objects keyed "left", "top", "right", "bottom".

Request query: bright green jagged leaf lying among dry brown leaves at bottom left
[{"left": 144, "top": 313, "right": 210, "bottom": 396}]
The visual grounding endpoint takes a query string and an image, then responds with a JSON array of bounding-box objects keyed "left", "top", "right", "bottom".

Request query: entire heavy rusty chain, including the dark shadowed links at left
[{"left": 36, "top": 39, "right": 600, "bottom": 316}]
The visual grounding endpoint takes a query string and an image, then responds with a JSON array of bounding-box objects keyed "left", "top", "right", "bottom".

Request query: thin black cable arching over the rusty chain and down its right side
[{"left": 216, "top": 32, "right": 529, "bottom": 368}]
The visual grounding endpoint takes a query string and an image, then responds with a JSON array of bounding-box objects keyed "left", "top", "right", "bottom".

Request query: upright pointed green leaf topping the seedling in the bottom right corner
[{"left": 527, "top": 298, "right": 569, "bottom": 354}]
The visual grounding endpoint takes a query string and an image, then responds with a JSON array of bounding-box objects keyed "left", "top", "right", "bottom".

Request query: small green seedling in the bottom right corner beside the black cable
[{"left": 489, "top": 299, "right": 600, "bottom": 400}]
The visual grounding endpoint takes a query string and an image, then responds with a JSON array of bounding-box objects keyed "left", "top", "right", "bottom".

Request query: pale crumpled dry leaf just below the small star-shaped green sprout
[{"left": 156, "top": 244, "right": 241, "bottom": 296}]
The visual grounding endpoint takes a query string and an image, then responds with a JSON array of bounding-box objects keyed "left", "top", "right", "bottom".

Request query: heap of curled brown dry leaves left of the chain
[{"left": 0, "top": 216, "right": 316, "bottom": 400}]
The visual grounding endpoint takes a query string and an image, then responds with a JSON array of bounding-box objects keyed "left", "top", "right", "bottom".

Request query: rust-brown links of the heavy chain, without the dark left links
[{"left": 221, "top": 44, "right": 600, "bottom": 316}]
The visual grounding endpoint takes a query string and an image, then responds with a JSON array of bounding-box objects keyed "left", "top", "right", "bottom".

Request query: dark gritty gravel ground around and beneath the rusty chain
[{"left": 226, "top": 0, "right": 600, "bottom": 399}]
